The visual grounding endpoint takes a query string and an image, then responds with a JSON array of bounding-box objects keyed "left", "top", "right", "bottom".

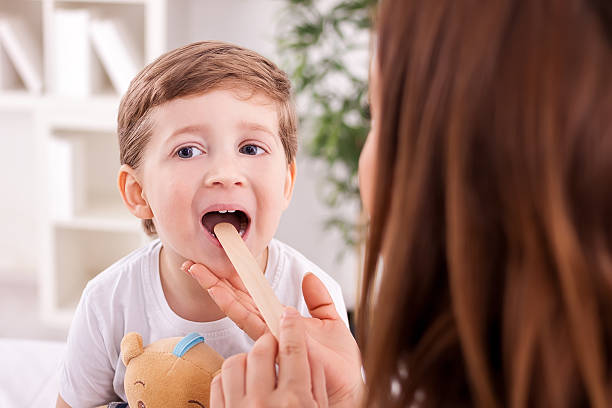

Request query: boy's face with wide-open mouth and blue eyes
[{"left": 141, "top": 89, "right": 295, "bottom": 277}]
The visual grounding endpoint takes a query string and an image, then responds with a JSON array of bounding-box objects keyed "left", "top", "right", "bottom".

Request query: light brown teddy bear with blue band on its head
[{"left": 100, "top": 332, "right": 223, "bottom": 408}]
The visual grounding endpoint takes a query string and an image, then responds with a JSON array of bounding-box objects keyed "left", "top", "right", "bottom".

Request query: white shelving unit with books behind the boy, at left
[{"left": 0, "top": 0, "right": 179, "bottom": 326}]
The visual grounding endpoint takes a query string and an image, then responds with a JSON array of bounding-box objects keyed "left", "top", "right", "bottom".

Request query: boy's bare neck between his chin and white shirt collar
[{"left": 159, "top": 245, "right": 268, "bottom": 322}]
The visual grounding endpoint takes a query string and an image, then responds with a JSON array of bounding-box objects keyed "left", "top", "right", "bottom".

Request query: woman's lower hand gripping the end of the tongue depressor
[{"left": 210, "top": 308, "right": 328, "bottom": 408}]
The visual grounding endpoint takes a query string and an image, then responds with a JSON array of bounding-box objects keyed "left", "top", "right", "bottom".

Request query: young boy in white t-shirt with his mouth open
[{"left": 58, "top": 42, "right": 346, "bottom": 407}]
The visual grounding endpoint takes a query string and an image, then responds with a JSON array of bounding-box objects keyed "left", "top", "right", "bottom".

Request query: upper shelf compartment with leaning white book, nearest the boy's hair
[{"left": 49, "top": 1, "right": 146, "bottom": 96}]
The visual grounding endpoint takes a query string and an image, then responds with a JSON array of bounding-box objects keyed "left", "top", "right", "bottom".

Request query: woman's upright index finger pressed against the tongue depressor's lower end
[{"left": 278, "top": 307, "right": 311, "bottom": 392}]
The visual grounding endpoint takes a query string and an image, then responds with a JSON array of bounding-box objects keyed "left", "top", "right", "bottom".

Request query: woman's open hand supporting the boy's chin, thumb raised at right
[{"left": 183, "top": 262, "right": 363, "bottom": 407}]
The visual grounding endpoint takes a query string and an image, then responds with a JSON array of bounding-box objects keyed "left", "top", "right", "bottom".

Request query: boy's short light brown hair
[{"left": 117, "top": 41, "right": 297, "bottom": 235}]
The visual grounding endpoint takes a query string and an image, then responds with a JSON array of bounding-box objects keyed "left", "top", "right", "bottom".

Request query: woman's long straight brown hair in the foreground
[{"left": 358, "top": 0, "right": 612, "bottom": 408}]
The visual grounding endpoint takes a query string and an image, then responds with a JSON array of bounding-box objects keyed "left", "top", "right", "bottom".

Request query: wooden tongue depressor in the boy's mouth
[{"left": 214, "top": 222, "right": 283, "bottom": 340}]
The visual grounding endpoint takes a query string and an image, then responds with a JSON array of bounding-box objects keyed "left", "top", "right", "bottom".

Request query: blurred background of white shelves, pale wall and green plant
[{"left": 0, "top": 0, "right": 372, "bottom": 341}]
